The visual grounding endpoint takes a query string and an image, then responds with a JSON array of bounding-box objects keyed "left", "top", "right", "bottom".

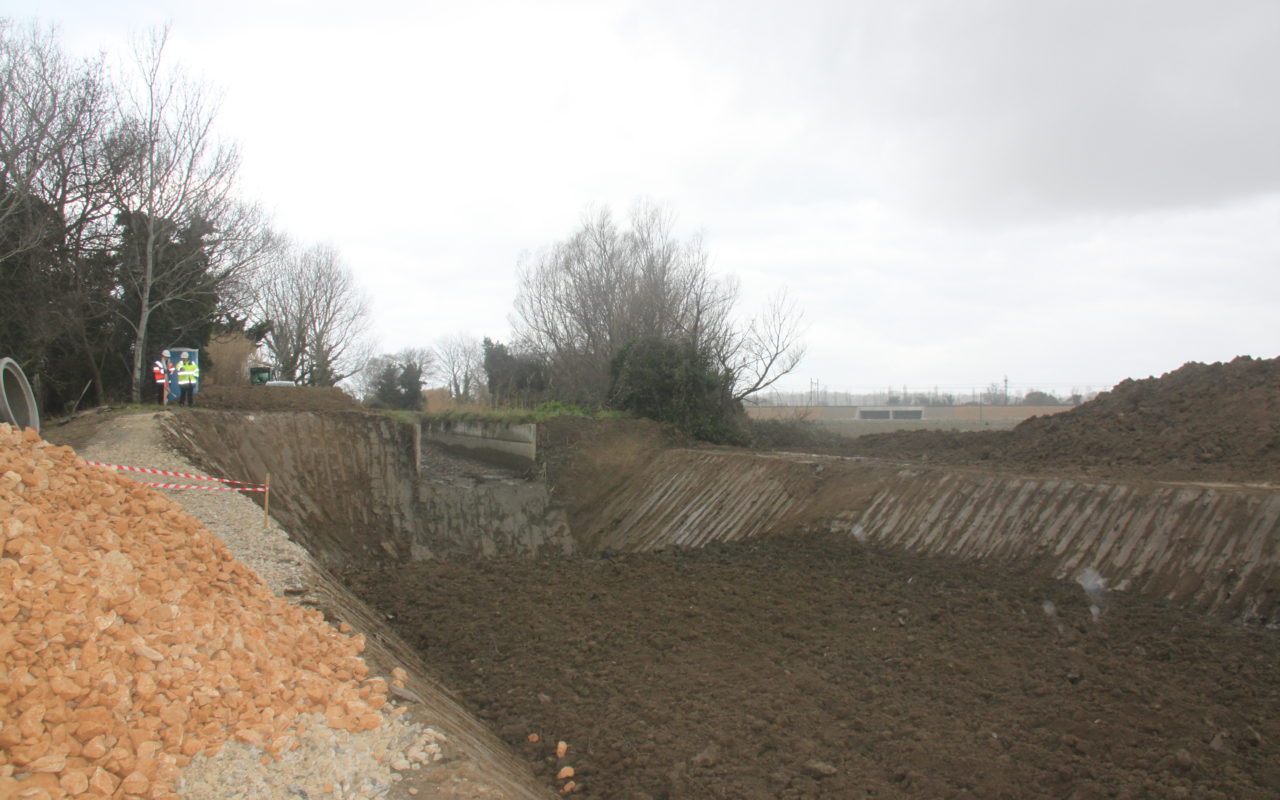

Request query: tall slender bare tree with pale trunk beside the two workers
[{"left": 110, "top": 28, "right": 264, "bottom": 402}]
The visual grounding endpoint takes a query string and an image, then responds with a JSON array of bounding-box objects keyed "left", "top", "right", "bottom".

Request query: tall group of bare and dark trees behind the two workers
[{"left": 0, "top": 19, "right": 367, "bottom": 412}]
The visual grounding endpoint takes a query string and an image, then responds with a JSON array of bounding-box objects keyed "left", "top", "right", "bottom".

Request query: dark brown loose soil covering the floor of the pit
[{"left": 346, "top": 535, "right": 1280, "bottom": 800}]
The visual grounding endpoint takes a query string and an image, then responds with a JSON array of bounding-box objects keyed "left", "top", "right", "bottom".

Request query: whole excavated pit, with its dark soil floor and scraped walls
[{"left": 170, "top": 411, "right": 1280, "bottom": 800}]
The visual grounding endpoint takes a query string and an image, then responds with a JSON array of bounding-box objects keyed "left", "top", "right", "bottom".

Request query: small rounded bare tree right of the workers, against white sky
[{"left": 255, "top": 238, "right": 369, "bottom": 387}]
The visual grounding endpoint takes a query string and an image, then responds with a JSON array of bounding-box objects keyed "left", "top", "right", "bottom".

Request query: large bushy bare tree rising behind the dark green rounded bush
[{"left": 513, "top": 202, "right": 804, "bottom": 403}]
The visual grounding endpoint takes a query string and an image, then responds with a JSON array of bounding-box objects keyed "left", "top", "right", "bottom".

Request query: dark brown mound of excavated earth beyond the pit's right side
[{"left": 838, "top": 357, "right": 1280, "bottom": 483}]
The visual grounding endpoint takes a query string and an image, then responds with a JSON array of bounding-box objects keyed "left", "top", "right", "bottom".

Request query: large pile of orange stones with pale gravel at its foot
[{"left": 0, "top": 417, "right": 443, "bottom": 799}]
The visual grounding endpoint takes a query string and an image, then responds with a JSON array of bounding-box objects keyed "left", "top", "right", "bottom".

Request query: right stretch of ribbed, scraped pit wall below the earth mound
[{"left": 833, "top": 468, "right": 1280, "bottom": 623}]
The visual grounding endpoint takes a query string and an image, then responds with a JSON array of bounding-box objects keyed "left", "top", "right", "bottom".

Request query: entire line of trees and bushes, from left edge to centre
[{"left": 0, "top": 20, "right": 804, "bottom": 439}]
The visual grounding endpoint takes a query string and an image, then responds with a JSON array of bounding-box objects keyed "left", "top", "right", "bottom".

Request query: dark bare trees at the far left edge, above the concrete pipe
[{"left": 0, "top": 19, "right": 114, "bottom": 396}]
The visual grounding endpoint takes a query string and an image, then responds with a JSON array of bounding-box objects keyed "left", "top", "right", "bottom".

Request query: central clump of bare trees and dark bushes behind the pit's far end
[{"left": 361, "top": 202, "right": 804, "bottom": 442}]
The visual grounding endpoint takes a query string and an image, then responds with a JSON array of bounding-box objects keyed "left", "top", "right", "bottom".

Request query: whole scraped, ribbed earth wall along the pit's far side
[{"left": 165, "top": 412, "right": 1280, "bottom": 623}]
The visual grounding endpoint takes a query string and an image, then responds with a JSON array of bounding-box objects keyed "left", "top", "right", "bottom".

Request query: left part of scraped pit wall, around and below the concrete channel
[{"left": 166, "top": 411, "right": 573, "bottom": 567}]
